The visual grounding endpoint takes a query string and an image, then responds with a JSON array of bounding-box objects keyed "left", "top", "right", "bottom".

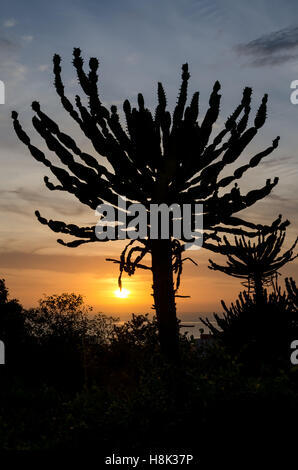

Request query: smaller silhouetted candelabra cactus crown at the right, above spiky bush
[{"left": 208, "top": 223, "right": 298, "bottom": 298}]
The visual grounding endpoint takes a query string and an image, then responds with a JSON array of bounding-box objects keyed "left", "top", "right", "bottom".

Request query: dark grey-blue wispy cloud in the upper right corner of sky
[{"left": 236, "top": 26, "right": 298, "bottom": 67}]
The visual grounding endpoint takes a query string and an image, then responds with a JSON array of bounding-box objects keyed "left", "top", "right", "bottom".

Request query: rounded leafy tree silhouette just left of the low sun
[{"left": 26, "top": 293, "right": 115, "bottom": 386}]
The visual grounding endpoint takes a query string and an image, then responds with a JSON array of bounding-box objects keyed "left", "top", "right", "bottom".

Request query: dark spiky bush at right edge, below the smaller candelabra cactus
[{"left": 201, "top": 278, "right": 298, "bottom": 372}]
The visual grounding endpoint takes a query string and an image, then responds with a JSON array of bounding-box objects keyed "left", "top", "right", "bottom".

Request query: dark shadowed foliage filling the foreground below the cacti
[{"left": 0, "top": 280, "right": 298, "bottom": 468}]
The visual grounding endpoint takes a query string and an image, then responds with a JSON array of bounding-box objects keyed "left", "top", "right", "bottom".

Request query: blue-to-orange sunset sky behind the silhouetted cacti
[{"left": 0, "top": 0, "right": 298, "bottom": 319}]
